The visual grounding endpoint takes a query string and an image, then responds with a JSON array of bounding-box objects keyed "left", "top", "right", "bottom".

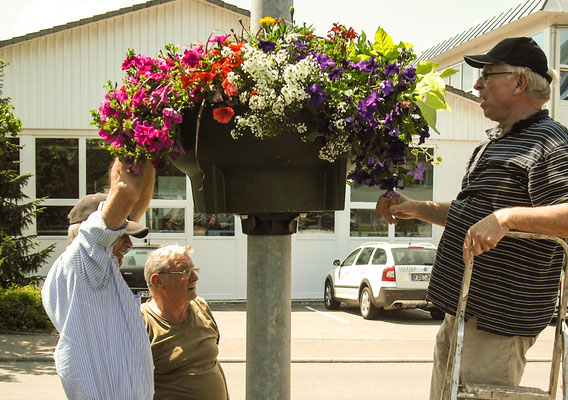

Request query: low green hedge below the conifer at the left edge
[{"left": 0, "top": 285, "right": 53, "bottom": 333}]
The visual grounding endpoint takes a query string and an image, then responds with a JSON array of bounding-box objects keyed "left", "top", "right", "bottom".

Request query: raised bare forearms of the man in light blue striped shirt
[{"left": 102, "top": 159, "right": 154, "bottom": 230}]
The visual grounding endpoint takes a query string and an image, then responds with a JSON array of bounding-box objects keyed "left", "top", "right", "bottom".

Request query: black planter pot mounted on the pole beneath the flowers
[{"left": 173, "top": 107, "right": 347, "bottom": 214}]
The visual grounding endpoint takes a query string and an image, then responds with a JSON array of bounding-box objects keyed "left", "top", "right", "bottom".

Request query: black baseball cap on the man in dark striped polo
[{"left": 464, "top": 37, "right": 552, "bottom": 83}]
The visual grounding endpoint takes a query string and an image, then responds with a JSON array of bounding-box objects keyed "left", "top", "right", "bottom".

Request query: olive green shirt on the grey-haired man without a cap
[{"left": 140, "top": 297, "right": 227, "bottom": 400}]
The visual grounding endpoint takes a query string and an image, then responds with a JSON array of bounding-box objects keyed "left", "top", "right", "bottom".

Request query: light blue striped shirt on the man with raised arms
[{"left": 42, "top": 203, "right": 154, "bottom": 400}]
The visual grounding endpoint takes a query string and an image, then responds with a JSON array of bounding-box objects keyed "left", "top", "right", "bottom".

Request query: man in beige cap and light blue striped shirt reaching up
[{"left": 42, "top": 160, "right": 154, "bottom": 400}]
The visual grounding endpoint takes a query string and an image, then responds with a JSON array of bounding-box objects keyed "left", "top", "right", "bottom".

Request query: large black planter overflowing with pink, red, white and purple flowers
[{"left": 92, "top": 17, "right": 451, "bottom": 214}]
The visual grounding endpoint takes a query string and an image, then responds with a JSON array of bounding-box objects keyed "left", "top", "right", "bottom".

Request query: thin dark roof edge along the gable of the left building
[{"left": 0, "top": 0, "right": 250, "bottom": 47}]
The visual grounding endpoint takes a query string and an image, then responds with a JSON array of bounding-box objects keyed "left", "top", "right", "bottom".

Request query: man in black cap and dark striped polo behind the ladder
[{"left": 377, "top": 37, "right": 568, "bottom": 400}]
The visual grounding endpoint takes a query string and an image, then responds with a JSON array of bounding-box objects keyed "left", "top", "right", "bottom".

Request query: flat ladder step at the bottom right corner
[{"left": 458, "top": 383, "right": 553, "bottom": 400}]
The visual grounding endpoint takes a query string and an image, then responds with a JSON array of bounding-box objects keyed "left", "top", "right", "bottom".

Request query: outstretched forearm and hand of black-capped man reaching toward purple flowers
[{"left": 377, "top": 192, "right": 450, "bottom": 226}]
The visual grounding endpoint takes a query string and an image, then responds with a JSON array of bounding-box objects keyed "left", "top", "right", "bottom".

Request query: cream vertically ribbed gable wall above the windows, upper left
[{"left": 0, "top": 0, "right": 249, "bottom": 130}]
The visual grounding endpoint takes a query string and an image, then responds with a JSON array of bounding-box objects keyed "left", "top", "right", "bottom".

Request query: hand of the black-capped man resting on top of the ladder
[{"left": 463, "top": 209, "right": 510, "bottom": 264}]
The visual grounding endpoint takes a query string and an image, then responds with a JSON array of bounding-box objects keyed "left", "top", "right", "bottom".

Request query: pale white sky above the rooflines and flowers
[{"left": 0, "top": 0, "right": 524, "bottom": 53}]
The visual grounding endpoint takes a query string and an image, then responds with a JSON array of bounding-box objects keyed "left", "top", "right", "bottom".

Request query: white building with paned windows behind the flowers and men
[{"left": 0, "top": 0, "right": 568, "bottom": 300}]
